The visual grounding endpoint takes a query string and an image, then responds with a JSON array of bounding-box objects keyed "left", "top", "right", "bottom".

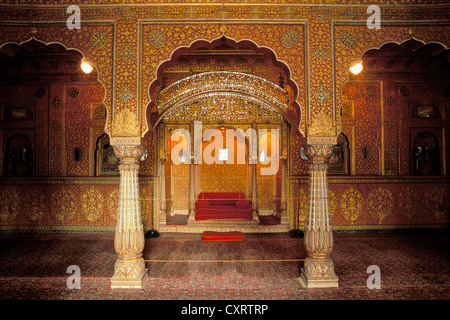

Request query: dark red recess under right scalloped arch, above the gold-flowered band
[{"left": 340, "top": 38, "right": 450, "bottom": 176}]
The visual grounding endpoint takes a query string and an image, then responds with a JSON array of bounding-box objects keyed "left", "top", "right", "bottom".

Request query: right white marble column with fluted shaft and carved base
[{"left": 299, "top": 138, "right": 338, "bottom": 288}]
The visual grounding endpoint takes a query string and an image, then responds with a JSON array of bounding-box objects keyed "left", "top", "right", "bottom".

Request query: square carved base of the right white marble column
[{"left": 298, "top": 258, "right": 339, "bottom": 289}]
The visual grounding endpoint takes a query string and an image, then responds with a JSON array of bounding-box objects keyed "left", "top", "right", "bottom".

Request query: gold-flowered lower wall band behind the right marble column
[{"left": 288, "top": 177, "right": 449, "bottom": 230}]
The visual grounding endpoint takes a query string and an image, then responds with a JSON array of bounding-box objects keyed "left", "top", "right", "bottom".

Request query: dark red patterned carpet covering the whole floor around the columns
[{"left": 0, "top": 233, "right": 450, "bottom": 300}]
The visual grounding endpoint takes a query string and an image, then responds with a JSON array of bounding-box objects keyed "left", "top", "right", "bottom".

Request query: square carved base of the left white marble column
[{"left": 111, "top": 258, "right": 148, "bottom": 289}]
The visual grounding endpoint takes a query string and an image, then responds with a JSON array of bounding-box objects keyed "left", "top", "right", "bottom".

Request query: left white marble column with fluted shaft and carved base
[{"left": 111, "top": 145, "right": 148, "bottom": 288}]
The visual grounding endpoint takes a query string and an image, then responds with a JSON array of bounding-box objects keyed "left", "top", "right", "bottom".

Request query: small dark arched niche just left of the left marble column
[{"left": 95, "top": 134, "right": 119, "bottom": 176}]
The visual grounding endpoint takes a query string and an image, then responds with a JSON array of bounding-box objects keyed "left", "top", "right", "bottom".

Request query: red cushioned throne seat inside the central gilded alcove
[{"left": 195, "top": 192, "right": 253, "bottom": 220}]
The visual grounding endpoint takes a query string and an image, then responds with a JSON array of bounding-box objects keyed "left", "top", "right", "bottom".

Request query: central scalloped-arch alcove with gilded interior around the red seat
[{"left": 147, "top": 37, "right": 298, "bottom": 232}]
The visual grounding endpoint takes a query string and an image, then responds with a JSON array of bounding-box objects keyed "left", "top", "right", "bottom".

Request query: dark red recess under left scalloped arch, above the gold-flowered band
[{"left": 0, "top": 37, "right": 107, "bottom": 177}]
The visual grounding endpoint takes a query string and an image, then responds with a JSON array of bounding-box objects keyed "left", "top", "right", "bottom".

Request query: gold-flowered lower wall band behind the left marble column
[{"left": 0, "top": 178, "right": 157, "bottom": 232}]
